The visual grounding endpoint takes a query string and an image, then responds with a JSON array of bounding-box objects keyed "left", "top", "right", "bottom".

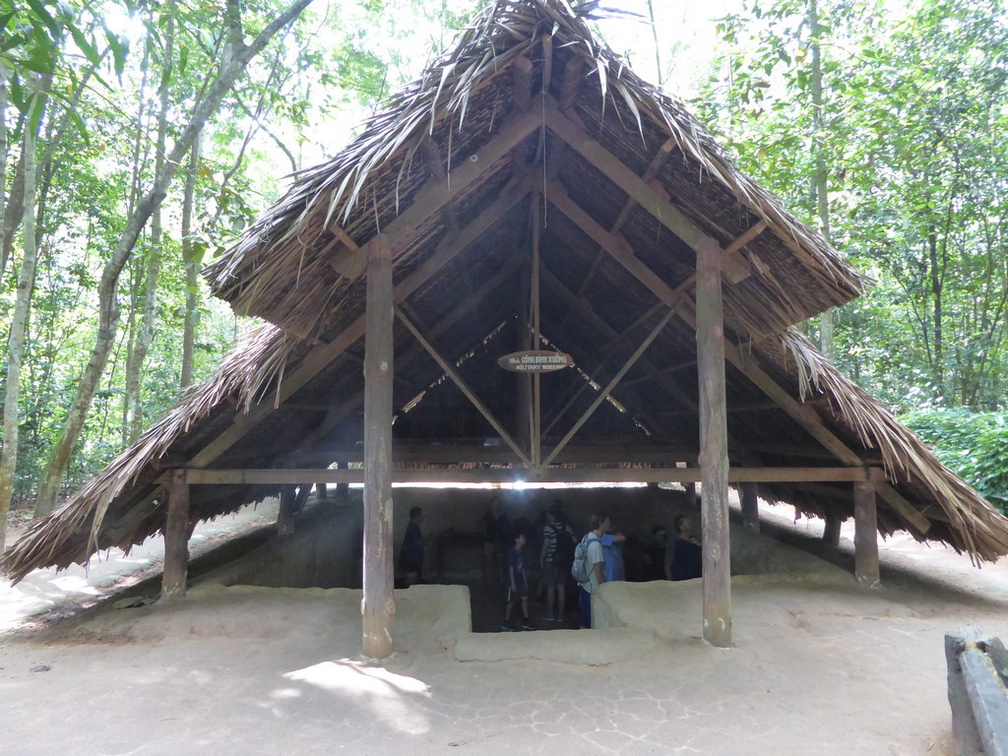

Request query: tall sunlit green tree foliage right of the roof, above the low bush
[{"left": 696, "top": 0, "right": 1008, "bottom": 410}]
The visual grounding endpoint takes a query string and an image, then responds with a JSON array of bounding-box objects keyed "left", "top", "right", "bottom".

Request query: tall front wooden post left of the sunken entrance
[{"left": 361, "top": 235, "right": 395, "bottom": 659}]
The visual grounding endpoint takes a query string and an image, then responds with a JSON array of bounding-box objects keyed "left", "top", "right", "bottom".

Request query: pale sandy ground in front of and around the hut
[{"left": 0, "top": 509, "right": 1008, "bottom": 755}]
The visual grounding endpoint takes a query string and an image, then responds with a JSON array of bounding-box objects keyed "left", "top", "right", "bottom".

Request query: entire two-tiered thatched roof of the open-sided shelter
[{"left": 3, "top": 0, "right": 1008, "bottom": 579}]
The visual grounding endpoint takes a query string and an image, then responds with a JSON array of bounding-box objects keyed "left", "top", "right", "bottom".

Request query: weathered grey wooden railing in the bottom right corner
[{"left": 946, "top": 627, "right": 1008, "bottom": 756}]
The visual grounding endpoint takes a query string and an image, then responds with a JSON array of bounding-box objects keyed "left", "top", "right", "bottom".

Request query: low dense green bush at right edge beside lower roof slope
[{"left": 900, "top": 408, "right": 1008, "bottom": 513}]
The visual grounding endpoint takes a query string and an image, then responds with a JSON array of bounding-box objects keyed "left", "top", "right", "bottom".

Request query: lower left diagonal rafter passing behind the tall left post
[{"left": 190, "top": 183, "right": 528, "bottom": 468}]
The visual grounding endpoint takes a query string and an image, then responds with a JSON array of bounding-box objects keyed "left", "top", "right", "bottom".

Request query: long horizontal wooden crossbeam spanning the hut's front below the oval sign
[{"left": 179, "top": 467, "right": 883, "bottom": 486}]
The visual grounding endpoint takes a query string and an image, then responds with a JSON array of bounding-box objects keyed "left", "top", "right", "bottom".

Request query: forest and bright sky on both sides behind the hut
[{"left": 0, "top": 0, "right": 1008, "bottom": 548}]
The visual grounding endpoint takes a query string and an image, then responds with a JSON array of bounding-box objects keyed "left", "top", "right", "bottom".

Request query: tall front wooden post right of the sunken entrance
[{"left": 697, "top": 238, "right": 732, "bottom": 648}]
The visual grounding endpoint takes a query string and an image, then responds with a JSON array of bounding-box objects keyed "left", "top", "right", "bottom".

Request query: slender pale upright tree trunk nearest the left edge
[{"left": 0, "top": 82, "right": 42, "bottom": 551}]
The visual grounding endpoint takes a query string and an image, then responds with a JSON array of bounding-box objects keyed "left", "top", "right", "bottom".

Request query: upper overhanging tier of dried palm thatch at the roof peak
[{"left": 207, "top": 0, "right": 862, "bottom": 337}]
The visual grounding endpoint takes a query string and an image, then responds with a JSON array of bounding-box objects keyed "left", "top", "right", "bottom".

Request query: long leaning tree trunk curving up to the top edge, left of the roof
[{"left": 35, "top": 0, "right": 311, "bottom": 517}]
